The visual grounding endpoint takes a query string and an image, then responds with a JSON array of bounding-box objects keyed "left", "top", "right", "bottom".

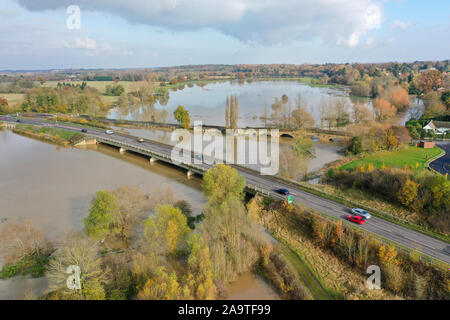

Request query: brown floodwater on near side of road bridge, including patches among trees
[{"left": 0, "top": 130, "right": 276, "bottom": 300}]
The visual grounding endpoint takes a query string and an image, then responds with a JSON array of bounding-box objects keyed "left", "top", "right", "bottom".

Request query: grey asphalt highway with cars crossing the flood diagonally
[{"left": 4, "top": 118, "right": 450, "bottom": 264}]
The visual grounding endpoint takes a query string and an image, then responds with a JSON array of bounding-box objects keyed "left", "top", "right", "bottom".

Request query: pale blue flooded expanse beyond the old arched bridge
[{"left": 108, "top": 81, "right": 371, "bottom": 127}]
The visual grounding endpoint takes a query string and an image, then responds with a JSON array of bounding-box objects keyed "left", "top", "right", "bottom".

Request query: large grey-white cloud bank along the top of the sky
[{"left": 16, "top": 0, "right": 382, "bottom": 47}]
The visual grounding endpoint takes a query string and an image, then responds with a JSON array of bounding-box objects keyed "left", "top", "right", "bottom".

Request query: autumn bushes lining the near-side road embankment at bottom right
[{"left": 253, "top": 198, "right": 450, "bottom": 300}]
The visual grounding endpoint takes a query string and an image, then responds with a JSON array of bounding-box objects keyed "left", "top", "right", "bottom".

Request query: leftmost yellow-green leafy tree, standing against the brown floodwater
[{"left": 84, "top": 191, "right": 117, "bottom": 241}]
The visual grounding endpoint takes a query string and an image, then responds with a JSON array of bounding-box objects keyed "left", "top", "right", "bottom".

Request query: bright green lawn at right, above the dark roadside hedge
[{"left": 340, "top": 146, "right": 442, "bottom": 170}]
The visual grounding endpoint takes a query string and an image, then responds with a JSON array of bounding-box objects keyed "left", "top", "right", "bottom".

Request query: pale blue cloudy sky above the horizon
[{"left": 0, "top": 0, "right": 450, "bottom": 70}]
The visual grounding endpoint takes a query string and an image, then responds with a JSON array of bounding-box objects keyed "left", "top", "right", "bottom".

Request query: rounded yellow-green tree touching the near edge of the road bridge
[{"left": 202, "top": 164, "right": 245, "bottom": 203}]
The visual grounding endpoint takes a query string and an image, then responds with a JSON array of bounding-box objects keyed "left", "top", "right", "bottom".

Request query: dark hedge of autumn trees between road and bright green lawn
[{"left": 327, "top": 167, "right": 450, "bottom": 234}]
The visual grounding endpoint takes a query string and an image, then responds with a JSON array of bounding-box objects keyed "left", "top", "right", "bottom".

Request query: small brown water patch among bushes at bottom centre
[{"left": 226, "top": 273, "right": 280, "bottom": 300}]
